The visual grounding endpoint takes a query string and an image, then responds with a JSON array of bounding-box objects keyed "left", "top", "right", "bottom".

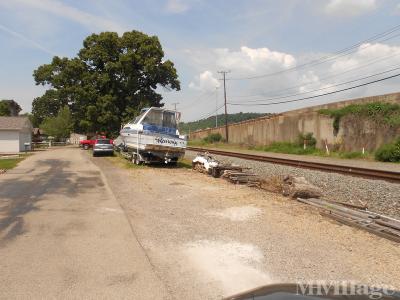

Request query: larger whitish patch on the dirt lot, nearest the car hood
[{"left": 183, "top": 240, "right": 272, "bottom": 296}]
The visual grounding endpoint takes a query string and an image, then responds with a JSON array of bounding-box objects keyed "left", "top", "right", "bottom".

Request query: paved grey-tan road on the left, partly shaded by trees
[{"left": 0, "top": 148, "right": 168, "bottom": 299}]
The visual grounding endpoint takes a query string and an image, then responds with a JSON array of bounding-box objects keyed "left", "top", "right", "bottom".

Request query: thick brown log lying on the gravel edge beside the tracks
[{"left": 283, "top": 176, "right": 322, "bottom": 199}]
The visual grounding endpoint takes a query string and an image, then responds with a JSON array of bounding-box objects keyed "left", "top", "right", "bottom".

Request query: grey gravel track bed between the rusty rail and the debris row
[{"left": 185, "top": 151, "right": 400, "bottom": 219}]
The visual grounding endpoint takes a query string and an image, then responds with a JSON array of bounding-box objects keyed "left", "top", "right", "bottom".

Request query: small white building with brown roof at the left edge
[{"left": 0, "top": 117, "right": 32, "bottom": 153}]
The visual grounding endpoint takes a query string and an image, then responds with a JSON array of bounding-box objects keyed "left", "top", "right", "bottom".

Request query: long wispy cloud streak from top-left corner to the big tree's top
[{"left": 0, "top": 0, "right": 124, "bottom": 33}]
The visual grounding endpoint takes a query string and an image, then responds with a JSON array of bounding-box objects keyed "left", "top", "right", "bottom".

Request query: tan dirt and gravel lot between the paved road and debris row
[{"left": 92, "top": 158, "right": 400, "bottom": 299}]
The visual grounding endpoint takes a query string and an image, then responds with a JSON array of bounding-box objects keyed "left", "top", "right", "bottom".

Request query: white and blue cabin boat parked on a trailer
[{"left": 115, "top": 107, "right": 187, "bottom": 164}]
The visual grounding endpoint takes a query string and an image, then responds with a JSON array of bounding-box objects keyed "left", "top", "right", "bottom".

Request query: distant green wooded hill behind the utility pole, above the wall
[{"left": 179, "top": 112, "right": 268, "bottom": 133}]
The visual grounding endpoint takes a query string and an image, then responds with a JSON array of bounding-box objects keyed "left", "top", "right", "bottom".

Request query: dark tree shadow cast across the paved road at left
[{"left": 0, "top": 159, "right": 103, "bottom": 246}]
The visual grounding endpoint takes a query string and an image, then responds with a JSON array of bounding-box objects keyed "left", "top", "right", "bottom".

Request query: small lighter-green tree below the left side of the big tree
[{"left": 40, "top": 106, "right": 73, "bottom": 140}]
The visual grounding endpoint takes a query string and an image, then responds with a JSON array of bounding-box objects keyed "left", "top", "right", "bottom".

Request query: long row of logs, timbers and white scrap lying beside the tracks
[{"left": 192, "top": 153, "right": 400, "bottom": 243}]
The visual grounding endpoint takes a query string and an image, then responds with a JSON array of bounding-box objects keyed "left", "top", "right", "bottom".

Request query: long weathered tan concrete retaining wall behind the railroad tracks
[{"left": 190, "top": 93, "right": 400, "bottom": 151}]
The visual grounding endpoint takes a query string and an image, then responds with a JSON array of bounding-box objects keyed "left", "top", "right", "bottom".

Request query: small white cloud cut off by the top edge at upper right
[{"left": 325, "top": 0, "right": 377, "bottom": 17}]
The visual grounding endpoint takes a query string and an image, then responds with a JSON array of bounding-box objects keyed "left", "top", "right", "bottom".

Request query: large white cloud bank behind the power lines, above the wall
[{"left": 180, "top": 43, "right": 400, "bottom": 119}]
